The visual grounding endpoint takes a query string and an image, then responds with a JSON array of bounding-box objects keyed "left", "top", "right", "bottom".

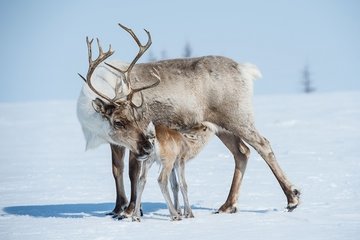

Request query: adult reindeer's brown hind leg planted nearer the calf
[{"left": 217, "top": 132, "right": 250, "bottom": 213}]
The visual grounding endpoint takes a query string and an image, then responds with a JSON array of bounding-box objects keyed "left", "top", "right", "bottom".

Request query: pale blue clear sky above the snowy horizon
[{"left": 0, "top": 0, "right": 360, "bottom": 102}]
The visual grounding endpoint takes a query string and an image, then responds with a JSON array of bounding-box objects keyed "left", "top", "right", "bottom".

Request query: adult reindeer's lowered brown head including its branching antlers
[{"left": 79, "top": 24, "right": 160, "bottom": 153}]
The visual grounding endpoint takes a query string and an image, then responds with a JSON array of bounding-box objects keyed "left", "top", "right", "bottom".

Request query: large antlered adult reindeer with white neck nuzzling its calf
[{"left": 78, "top": 24, "right": 300, "bottom": 218}]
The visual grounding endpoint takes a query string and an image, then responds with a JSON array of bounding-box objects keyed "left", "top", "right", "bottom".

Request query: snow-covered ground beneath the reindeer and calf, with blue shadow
[{"left": 0, "top": 92, "right": 360, "bottom": 240}]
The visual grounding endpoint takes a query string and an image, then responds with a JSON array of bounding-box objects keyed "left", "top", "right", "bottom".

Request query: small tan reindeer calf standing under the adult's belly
[{"left": 132, "top": 122, "right": 214, "bottom": 221}]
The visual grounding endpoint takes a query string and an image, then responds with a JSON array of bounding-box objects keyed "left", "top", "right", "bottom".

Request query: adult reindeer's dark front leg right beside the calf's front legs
[{"left": 117, "top": 152, "right": 141, "bottom": 220}]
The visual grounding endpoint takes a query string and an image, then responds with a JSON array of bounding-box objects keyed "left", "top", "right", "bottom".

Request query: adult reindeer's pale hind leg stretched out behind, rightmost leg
[{"left": 241, "top": 127, "right": 300, "bottom": 211}]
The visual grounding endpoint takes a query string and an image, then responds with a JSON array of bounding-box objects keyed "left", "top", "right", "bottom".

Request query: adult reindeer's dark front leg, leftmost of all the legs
[{"left": 108, "top": 144, "right": 128, "bottom": 216}]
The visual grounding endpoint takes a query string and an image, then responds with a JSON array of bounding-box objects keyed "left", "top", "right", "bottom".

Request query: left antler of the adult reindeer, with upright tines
[{"left": 78, "top": 37, "right": 114, "bottom": 103}]
